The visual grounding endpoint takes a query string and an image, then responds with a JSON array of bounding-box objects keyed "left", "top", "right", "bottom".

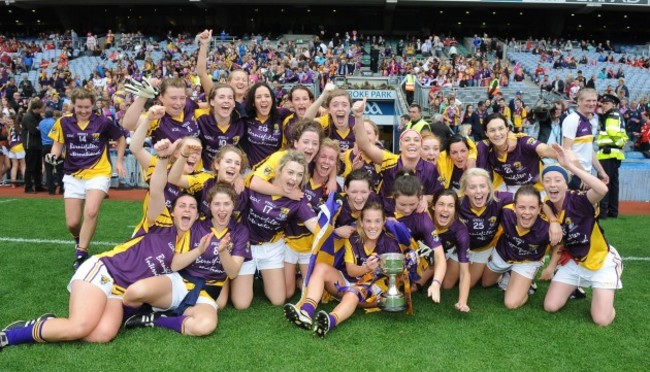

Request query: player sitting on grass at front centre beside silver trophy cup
[{"left": 284, "top": 203, "right": 401, "bottom": 337}]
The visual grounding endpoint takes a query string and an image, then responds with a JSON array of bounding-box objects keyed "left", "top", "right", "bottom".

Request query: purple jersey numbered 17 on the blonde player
[{"left": 242, "top": 188, "right": 316, "bottom": 245}]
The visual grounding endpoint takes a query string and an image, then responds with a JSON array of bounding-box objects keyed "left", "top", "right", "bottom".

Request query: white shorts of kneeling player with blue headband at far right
[{"left": 553, "top": 245, "right": 623, "bottom": 289}]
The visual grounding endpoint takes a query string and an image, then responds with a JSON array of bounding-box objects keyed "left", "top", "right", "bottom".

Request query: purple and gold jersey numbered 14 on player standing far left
[{"left": 49, "top": 114, "right": 124, "bottom": 180}]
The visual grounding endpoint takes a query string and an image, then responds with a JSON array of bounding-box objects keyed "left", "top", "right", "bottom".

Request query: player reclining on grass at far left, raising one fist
[{"left": 0, "top": 140, "right": 198, "bottom": 349}]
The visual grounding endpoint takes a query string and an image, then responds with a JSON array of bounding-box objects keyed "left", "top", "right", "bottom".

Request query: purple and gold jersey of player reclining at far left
[{"left": 96, "top": 227, "right": 189, "bottom": 292}]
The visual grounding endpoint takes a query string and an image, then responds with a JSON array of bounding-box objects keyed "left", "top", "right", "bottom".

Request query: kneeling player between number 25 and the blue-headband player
[{"left": 483, "top": 185, "right": 550, "bottom": 309}]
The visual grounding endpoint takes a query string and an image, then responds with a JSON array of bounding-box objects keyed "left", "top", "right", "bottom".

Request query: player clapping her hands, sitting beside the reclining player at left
[{"left": 124, "top": 183, "right": 251, "bottom": 336}]
